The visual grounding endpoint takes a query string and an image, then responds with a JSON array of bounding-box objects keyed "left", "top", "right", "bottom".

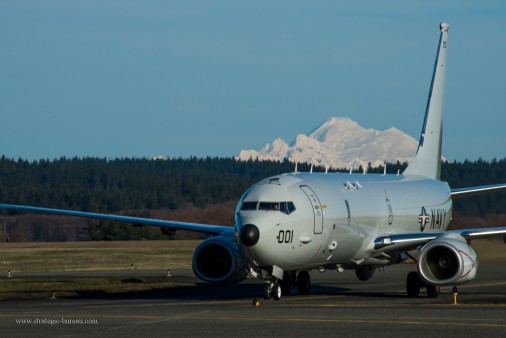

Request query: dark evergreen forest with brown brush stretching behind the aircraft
[{"left": 0, "top": 157, "right": 506, "bottom": 241}]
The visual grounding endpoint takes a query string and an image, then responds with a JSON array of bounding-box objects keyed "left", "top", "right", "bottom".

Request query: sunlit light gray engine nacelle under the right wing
[{"left": 417, "top": 233, "right": 478, "bottom": 285}]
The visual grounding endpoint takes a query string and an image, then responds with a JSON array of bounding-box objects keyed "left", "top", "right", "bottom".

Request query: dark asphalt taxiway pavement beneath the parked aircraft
[{"left": 0, "top": 263, "right": 506, "bottom": 337}]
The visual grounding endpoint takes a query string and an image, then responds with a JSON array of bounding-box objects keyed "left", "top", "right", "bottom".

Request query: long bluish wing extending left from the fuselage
[{"left": 0, "top": 204, "right": 233, "bottom": 235}]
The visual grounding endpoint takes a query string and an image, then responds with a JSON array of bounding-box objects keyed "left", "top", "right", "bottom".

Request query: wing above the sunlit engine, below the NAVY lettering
[{"left": 374, "top": 227, "right": 506, "bottom": 253}]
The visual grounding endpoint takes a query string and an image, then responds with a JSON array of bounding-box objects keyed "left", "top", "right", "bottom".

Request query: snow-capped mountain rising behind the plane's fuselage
[{"left": 237, "top": 117, "right": 418, "bottom": 168}]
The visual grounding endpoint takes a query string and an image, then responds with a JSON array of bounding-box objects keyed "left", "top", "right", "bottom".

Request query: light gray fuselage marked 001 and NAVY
[{"left": 236, "top": 173, "right": 452, "bottom": 271}]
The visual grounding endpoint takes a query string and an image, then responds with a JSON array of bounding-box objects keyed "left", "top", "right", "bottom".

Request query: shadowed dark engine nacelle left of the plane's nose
[{"left": 192, "top": 233, "right": 249, "bottom": 284}]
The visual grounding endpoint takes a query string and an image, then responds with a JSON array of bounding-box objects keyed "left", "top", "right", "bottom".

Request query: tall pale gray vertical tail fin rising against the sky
[{"left": 404, "top": 22, "right": 449, "bottom": 179}]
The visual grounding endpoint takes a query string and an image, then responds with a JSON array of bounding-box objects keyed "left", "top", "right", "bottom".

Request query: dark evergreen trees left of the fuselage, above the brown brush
[{"left": 0, "top": 157, "right": 308, "bottom": 212}]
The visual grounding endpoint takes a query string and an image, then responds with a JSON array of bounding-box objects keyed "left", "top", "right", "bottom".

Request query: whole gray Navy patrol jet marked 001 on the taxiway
[{"left": 0, "top": 23, "right": 506, "bottom": 300}]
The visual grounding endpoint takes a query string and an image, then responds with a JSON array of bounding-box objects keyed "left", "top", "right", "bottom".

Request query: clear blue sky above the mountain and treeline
[{"left": 0, "top": 0, "right": 506, "bottom": 160}]
